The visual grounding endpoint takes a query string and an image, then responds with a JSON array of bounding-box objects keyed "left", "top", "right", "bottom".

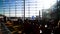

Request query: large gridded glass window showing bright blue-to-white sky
[{"left": 0, "top": 0, "right": 57, "bottom": 17}]
